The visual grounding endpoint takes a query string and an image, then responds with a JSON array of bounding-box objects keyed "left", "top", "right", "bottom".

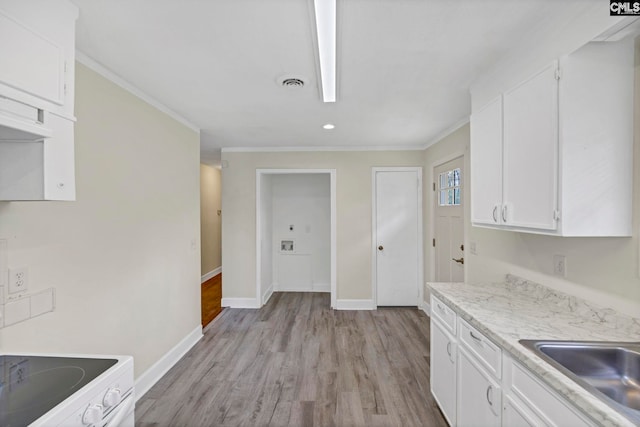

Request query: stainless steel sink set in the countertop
[{"left": 520, "top": 340, "right": 640, "bottom": 425}]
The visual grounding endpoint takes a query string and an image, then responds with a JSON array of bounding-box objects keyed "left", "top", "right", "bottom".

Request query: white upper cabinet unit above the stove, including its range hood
[{"left": 0, "top": 0, "right": 78, "bottom": 201}]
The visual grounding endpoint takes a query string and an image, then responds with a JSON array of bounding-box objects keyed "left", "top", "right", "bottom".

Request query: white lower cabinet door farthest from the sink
[{"left": 430, "top": 318, "right": 456, "bottom": 426}]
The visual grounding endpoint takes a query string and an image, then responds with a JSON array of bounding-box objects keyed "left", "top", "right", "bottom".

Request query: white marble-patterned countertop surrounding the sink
[{"left": 429, "top": 275, "right": 640, "bottom": 427}]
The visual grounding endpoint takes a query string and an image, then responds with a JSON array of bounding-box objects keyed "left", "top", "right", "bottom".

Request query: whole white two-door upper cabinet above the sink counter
[{"left": 471, "top": 39, "right": 634, "bottom": 236}]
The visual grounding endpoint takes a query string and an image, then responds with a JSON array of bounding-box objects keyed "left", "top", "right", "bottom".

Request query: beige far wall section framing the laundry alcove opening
[{"left": 222, "top": 150, "right": 424, "bottom": 300}]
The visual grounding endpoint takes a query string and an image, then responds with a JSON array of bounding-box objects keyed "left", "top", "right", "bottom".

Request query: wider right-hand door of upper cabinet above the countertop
[{"left": 501, "top": 62, "right": 558, "bottom": 230}]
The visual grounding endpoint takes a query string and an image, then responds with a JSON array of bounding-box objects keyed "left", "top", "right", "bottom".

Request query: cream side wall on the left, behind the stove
[{"left": 0, "top": 64, "right": 200, "bottom": 377}]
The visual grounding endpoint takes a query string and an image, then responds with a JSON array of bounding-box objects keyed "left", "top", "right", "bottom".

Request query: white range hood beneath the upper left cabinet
[{"left": 0, "top": 96, "right": 53, "bottom": 142}]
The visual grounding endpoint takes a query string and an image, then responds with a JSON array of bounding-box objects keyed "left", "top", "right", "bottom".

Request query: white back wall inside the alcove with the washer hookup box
[{"left": 272, "top": 174, "right": 331, "bottom": 292}]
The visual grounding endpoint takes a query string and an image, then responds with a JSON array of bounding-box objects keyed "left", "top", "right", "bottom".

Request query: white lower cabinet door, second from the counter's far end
[{"left": 457, "top": 346, "right": 502, "bottom": 427}]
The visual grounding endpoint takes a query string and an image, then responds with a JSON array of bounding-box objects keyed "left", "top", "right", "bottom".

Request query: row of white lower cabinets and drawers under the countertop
[{"left": 430, "top": 296, "right": 595, "bottom": 427}]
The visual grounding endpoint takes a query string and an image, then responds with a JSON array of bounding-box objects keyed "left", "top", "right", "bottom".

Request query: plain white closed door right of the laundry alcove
[{"left": 374, "top": 168, "right": 422, "bottom": 306}]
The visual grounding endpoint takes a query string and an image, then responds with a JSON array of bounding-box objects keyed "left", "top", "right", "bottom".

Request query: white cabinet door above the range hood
[{"left": 0, "top": 11, "right": 64, "bottom": 105}]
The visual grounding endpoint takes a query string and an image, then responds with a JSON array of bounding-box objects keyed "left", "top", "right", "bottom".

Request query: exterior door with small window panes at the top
[{"left": 434, "top": 157, "right": 464, "bottom": 282}]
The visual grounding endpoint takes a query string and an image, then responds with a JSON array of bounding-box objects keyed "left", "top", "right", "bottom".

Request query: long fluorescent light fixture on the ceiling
[{"left": 313, "top": 0, "right": 336, "bottom": 102}]
